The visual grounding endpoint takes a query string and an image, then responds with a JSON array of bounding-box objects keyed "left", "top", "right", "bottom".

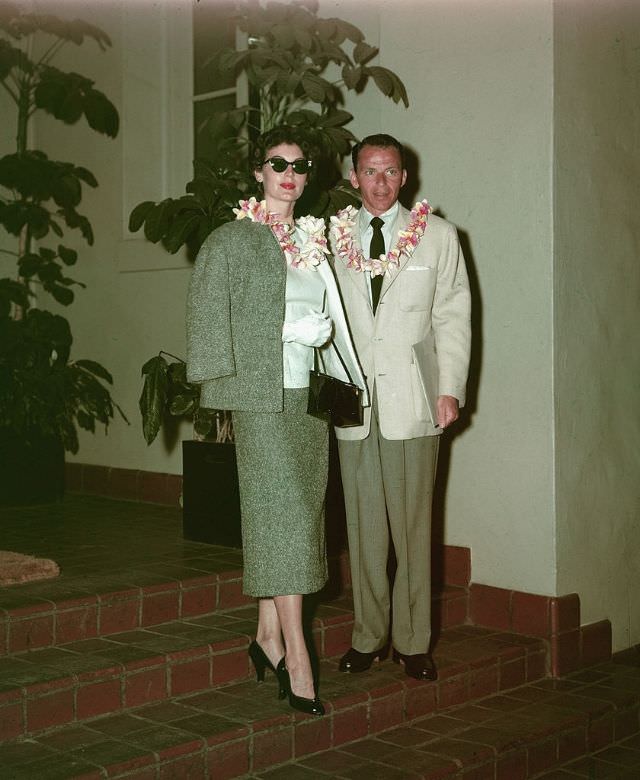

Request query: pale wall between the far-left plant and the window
[{"left": 29, "top": 0, "right": 191, "bottom": 473}]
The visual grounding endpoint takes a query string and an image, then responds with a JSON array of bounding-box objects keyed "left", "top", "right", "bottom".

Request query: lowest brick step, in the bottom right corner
[{"left": 260, "top": 662, "right": 640, "bottom": 780}]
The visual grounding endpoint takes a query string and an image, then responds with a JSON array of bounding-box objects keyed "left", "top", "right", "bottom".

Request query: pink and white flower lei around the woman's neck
[{"left": 233, "top": 198, "right": 331, "bottom": 270}]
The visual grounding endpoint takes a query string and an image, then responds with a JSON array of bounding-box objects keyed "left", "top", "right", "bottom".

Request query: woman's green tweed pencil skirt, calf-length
[{"left": 233, "top": 388, "right": 329, "bottom": 597}]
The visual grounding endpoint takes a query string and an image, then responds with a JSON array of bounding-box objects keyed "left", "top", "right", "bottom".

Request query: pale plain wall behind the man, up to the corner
[{"left": 332, "top": 0, "right": 555, "bottom": 593}]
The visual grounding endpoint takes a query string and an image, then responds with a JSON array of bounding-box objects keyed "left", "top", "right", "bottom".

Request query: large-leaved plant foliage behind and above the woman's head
[{"left": 129, "top": 0, "right": 408, "bottom": 255}]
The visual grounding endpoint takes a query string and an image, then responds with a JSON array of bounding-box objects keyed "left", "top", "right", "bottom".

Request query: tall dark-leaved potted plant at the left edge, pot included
[{"left": 0, "top": 2, "right": 124, "bottom": 504}]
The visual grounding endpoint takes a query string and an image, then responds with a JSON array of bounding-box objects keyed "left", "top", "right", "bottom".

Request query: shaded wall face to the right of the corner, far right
[{"left": 554, "top": 2, "right": 640, "bottom": 647}]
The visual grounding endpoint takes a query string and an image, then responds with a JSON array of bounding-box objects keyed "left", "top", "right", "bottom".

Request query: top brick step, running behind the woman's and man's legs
[{"left": 0, "top": 542, "right": 469, "bottom": 657}]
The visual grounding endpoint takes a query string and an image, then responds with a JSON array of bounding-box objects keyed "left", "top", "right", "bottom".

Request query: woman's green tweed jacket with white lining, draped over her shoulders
[{"left": 187, "top": 219, "right": 369, "bottom": 412}]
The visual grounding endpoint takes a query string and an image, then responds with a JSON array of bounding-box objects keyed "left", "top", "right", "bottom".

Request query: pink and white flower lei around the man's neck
[{"left": 331, "top": 200, "right": 432, "bottom": 276}]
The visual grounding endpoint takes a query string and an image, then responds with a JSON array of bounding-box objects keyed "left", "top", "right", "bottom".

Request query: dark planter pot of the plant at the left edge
[{"left": 0, "top": 428, "right": 64, "bottom": 506}]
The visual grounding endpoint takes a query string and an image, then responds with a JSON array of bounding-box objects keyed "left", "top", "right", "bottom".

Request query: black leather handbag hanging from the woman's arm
[{"left": 307, "top": 342, "right": 363, "bottom": 428}]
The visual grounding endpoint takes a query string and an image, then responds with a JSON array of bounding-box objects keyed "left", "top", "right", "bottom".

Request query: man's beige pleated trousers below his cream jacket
[{"left": 338, "top": 409, "right": 439, "bottom": 655}]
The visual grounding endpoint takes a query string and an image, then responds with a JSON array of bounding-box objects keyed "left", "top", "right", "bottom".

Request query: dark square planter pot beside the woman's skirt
[{"left": 182, "top": 441, "right": 242, "bottom": 547}]
